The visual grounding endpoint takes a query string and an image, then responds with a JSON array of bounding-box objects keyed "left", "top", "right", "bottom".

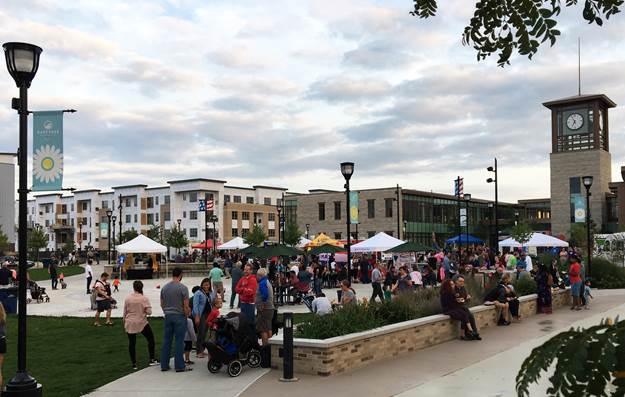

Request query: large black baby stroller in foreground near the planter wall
[{"left": 204, "top": 312, "right": 261, "bottom": 377}]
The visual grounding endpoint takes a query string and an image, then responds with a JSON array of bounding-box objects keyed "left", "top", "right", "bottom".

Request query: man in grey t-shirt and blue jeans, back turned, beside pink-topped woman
[{"left": 161, "top": 267, "right": 192, "bottom": 372}]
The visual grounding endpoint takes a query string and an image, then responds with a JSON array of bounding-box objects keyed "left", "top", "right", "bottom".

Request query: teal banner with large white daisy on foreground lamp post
[{"left": 32, "top": 110, "right": 63, "bottom": 192}]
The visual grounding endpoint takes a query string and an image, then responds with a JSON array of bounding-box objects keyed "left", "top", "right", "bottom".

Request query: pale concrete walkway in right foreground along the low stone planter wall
[{"left": 242, "top": 290, "right": 625, "bottom": 397}]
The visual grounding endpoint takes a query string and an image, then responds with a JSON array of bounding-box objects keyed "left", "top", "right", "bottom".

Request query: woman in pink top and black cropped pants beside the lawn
[{"left": 124, "top": 280, "right": 158, "bottom": 369}]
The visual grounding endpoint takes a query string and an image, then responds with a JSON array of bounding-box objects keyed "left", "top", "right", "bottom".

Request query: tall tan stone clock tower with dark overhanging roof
[{"left": 543, "top": 94, "right": 616, "bottom": 236}]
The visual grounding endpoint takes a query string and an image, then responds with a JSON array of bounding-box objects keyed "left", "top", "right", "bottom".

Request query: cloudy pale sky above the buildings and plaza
[{"left": 0, "top": 0, "right": 625, "bottom": 201}]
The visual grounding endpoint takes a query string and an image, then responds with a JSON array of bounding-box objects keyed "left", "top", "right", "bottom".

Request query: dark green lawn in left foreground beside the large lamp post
[{"left": 2, "top": 315, "right": 163, "bottom": 397}]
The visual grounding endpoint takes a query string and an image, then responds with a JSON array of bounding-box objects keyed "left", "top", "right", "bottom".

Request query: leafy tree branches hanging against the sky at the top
[{"left": 410, "top": 0, "right": 624, "bottom": 66}]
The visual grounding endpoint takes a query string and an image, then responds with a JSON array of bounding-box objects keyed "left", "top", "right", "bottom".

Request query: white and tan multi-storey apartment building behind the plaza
[{"left": 21, "top": 178, "right": 286, "bottom": 251}]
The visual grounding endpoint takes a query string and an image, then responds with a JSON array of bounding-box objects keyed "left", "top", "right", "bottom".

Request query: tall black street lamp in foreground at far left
[{"left": 2, "top": 39, "right": 43, "bottom": 396}]
